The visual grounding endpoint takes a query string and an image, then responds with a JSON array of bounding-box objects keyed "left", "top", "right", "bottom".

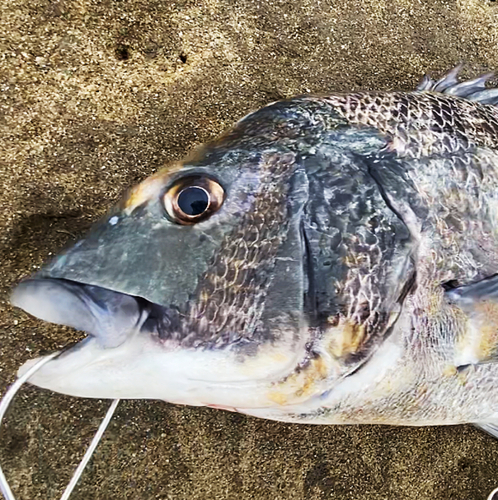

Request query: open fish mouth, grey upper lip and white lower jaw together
[{"left": 11, "top": 276, "right": 304, "bottom": 407}]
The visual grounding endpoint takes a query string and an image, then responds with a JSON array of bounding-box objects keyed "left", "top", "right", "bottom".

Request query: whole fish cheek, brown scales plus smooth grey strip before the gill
[{"left": 177, "top": 153, "right": 310, "bottom": 348}]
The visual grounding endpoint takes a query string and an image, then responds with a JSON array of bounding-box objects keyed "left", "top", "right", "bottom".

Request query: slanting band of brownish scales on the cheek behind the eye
[{"left": 184, "top": 154, "right": 293, "bottom": 345}]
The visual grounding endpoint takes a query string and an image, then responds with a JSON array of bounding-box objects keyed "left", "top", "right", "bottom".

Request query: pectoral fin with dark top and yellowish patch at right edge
[{"left": 446, "top": 276, "right": 498, "bottom": 366}]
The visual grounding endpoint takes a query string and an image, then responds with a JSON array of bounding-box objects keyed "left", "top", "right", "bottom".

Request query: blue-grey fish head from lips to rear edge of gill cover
[{"left": 12, "top": 98, "right": 411, "bottom": 408}]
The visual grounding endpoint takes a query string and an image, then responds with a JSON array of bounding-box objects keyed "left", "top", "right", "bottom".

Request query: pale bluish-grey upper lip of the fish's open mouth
[{"left": 11, "top": 278, "right": 152, "bottom": 349}]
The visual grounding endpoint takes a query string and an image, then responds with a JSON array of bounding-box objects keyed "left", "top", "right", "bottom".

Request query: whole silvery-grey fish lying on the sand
[{"left": 7, "top": 66, "right": 498, "bottom": 437}]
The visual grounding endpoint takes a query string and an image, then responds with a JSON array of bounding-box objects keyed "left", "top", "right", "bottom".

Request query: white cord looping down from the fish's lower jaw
[{"left": 0, "top": 352, "right": 119, "bottom": 500}]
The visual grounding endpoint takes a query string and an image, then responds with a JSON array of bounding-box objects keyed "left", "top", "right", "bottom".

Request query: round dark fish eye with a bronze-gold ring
[{"left": 163, "top": 176, "right": 225, "bottom": 224}]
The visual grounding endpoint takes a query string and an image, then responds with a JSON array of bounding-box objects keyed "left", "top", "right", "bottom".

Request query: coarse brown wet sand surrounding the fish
[{"left": 0, "top": 0, "right": 498, "bottom": 500}]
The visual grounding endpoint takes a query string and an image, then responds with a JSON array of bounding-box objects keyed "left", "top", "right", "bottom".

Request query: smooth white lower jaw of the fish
[{"left": 14, "top": 322, "right": 312, "bottom": 408}]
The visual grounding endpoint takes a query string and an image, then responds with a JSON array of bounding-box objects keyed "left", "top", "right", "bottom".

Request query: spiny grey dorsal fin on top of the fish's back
[{"left": 416, "top": 64, "right": 498, "bottom": 106}]
